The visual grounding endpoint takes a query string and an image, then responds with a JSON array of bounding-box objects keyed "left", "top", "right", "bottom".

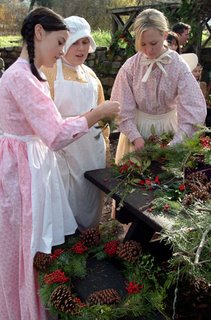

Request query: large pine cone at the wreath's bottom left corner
[{"left": 50, "top": 285, "right": 78, "bottom": 314}]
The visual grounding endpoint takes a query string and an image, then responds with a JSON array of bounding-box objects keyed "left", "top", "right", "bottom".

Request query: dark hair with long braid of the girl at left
[{"left": 21, "top": 7, "right": 68, "bottom": 81}]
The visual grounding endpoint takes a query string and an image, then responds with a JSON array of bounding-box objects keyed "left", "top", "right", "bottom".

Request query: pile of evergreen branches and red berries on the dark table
[{"left": 109, "top": 127, "right": 211, "bottom": 319}]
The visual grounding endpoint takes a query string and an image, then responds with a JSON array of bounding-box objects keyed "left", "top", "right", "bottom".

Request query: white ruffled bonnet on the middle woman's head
[{"left": 64, "top": 16, "right": 96, "bottom": 54}]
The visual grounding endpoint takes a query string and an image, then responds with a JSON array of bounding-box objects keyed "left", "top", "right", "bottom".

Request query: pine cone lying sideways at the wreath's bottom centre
[{"left": 88, "top": 289, "right": 121, "bottom": 305}]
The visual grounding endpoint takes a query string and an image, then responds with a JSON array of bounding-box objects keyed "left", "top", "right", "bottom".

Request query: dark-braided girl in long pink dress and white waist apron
[{"left": 0, "top": 8, "right": 119, "bottom": 320}]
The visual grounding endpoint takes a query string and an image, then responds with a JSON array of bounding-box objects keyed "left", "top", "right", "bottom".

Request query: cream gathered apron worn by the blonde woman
[{"left": 115, "top": 109, "right": 177, "bottom": 164}]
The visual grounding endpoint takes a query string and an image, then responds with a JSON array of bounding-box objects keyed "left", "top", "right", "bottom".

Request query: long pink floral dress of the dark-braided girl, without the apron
[{"left": 0, "top": 59, "right": 88, "bottom": 320}]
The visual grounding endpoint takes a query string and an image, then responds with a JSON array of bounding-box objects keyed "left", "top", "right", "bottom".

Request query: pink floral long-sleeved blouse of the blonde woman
[{"left": 111, "top": 50, "right": 206, "bottom": 143}]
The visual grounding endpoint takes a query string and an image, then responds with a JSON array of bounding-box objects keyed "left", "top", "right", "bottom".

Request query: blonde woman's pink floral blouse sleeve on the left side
[{"left": 111, "top": 65, "right": 140, "bottom": 142}]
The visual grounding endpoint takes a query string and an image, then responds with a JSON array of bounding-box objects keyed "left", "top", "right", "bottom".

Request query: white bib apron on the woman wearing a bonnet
[{"left": 54, "top": 60, "right": 106, "bottom": 230}]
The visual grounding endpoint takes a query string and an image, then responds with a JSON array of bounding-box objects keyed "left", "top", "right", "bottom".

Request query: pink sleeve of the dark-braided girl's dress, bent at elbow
[{"left": 7, "top": 70, "right": 88, "bottom": 151}]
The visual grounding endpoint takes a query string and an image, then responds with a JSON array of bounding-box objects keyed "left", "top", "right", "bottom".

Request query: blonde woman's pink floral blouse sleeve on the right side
[{"left": 171, "top": 71, "right": 207, "bottom": 144}]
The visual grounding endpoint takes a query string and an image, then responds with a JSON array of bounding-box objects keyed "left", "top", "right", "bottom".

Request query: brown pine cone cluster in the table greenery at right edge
[{"left": 183, "top": 171, "right": 211, "bottom": 206}]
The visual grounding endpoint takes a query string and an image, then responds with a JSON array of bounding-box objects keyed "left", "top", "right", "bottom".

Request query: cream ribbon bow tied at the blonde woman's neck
[{"left": 140, "top": 50, "right": 172, "bottom": 82}]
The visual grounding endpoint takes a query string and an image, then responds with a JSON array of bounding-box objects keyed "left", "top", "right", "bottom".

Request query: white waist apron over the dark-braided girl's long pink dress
[{"left": 2, "top": 133, "right": 77, "bottom": 256}]
